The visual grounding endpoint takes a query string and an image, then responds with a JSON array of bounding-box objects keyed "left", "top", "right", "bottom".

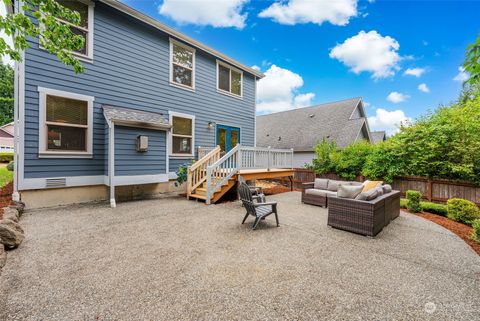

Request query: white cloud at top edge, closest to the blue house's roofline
[{"left": 158, "top": 0, "right": 248, "bottom": 29}]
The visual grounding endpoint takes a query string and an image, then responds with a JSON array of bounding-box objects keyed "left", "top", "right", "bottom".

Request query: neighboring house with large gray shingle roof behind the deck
[{"left": 256, "top": 98, "right": 372, "bottom": 167}]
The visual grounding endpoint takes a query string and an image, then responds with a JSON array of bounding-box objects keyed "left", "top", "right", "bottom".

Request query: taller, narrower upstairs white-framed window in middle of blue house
[{"left": 170, "top": 38, "right": 195, "bottom": 90}]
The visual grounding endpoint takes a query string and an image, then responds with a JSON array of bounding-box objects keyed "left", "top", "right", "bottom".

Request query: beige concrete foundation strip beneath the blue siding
[{"left": 20, "top": 181, "right": 186, "bottom": 209}]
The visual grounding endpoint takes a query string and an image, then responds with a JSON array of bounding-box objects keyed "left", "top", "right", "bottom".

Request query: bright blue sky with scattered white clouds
[{"left": 121, "top": 0, "right": 480, "bottom": 132}]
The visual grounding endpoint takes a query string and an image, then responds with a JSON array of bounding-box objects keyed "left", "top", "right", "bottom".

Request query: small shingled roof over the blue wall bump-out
[{"left": 102, "top": 105, "right": 171, "bottom": 128}]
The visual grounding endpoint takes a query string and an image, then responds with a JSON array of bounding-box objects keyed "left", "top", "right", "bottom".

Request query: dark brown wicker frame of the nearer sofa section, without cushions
[{"left": 328, "top": 191, "right": 400, "bottom": 236}]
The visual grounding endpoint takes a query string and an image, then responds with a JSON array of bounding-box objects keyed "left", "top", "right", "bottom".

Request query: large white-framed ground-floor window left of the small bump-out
[{"left": 38, "top": 87, "right": 95, "bottom": 158}]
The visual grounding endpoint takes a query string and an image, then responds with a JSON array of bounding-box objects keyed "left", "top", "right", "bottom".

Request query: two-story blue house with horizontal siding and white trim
[{"left": 14, "top": 0, "right": 263, "bottom": 207}]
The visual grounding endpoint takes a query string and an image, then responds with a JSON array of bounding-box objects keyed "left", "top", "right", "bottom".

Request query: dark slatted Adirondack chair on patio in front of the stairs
[{"left": 239, "top": 182, "right": 280, "bottom": 230}]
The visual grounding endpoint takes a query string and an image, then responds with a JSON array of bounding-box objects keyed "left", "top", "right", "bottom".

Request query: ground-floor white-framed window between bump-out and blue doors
[{"left": 169, "top": 111, "right": 195, "bottom": 157}]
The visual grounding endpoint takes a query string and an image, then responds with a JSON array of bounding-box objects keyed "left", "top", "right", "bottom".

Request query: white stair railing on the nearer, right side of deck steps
[{"left": 205, "top": 144, "right": 241, "bottom": 204}]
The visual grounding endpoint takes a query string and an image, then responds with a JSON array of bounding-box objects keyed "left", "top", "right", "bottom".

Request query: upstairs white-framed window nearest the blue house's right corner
[{"left": 217, "top": 60, "right": 243, "bottom": 98}]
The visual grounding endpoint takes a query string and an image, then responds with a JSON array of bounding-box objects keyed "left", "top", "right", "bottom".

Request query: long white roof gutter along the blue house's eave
[{"left": 100, "top": 0, "right": 265, "bottom": 78}]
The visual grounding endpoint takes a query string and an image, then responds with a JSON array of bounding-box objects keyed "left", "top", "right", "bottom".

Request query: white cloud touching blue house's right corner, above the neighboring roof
[{"left": 257, "top": 65, "right": 315, "bottom": 114}]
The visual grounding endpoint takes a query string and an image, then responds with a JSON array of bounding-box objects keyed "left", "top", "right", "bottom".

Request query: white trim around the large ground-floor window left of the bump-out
[{"left": 38, "top": 87, "right": 95, "bottom": 158}]
